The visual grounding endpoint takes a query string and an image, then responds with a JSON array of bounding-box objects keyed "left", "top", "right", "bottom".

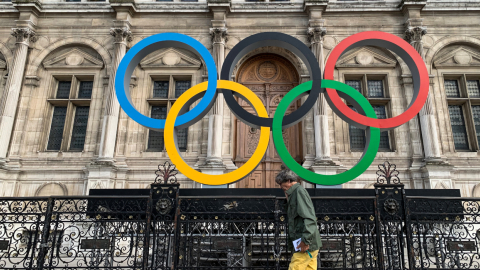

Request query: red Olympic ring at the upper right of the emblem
[{"left": 324, "top": 31, "right": 430, "bottom": 130}]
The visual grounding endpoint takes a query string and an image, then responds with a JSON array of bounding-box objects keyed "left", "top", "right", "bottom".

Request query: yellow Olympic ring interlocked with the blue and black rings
[{"left": 164, "top": 80, "right": 270, "bottom": 185}]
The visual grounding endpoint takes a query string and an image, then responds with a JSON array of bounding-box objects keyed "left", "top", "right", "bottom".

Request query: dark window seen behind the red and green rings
[{"left": 345, "top": 75, "right": 391, "bottom": 151}]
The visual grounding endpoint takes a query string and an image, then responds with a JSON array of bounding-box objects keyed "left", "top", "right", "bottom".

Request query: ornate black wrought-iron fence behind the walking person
[{"left": 0, "top": 161, "right": 480, "bottom": 270}]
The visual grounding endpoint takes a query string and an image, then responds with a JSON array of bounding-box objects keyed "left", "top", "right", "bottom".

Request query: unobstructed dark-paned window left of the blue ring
[{"left": 47, "top": 76, "right": 93, "bottom": 151}]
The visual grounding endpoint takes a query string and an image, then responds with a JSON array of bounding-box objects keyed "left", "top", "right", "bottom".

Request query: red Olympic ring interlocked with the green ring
[{"left": 325, "top": 31, "right": 430, "bottom": 131}]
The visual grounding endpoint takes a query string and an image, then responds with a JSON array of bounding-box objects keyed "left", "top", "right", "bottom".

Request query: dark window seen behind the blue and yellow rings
[{"left": 147, "top": 76, "right": 192, "bottom": 152}]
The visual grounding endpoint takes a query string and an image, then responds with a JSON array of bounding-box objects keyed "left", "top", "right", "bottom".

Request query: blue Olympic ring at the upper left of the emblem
[{"left": 115, "top": 33, "right": 217, "bottom": 130}]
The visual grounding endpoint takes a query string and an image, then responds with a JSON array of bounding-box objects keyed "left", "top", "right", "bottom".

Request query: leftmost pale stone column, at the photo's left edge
[{"left": 0, "top": 27, "right": 35, "bottom": 163}]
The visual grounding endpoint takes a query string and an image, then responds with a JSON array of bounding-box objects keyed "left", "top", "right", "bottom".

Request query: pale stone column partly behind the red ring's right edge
[{"left": 405, "top": 26, "right": 442, "bottom": 163}]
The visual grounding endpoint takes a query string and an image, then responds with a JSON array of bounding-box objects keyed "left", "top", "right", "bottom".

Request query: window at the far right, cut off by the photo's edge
[{"left": 443, "top": 74, "right": 480, "bottom": 151}]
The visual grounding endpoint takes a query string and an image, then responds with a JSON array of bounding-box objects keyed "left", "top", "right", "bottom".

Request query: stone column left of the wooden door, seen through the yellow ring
[{"left": 199, "top": 27, "right": 228, "bottom": 174}]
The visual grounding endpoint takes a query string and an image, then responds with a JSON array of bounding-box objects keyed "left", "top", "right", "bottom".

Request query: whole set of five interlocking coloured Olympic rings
[{"left": 115, "top": 31, "right": 429, "bottom": 185}]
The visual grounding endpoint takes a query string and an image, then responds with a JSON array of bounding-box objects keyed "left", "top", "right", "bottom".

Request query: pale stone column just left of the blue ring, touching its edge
[{"left": 98, "top": 26, "right": 132, "bottom": 164}]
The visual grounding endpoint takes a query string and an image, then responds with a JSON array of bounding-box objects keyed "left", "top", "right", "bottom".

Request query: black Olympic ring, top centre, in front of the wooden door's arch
[{"left": 220, "top": 32, "right": 322, "bottom": 128}]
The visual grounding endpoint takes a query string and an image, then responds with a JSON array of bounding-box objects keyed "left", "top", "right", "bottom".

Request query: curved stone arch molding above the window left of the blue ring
[{"left": 27, "top": 37, "right": 112, "bottom": 76}]
